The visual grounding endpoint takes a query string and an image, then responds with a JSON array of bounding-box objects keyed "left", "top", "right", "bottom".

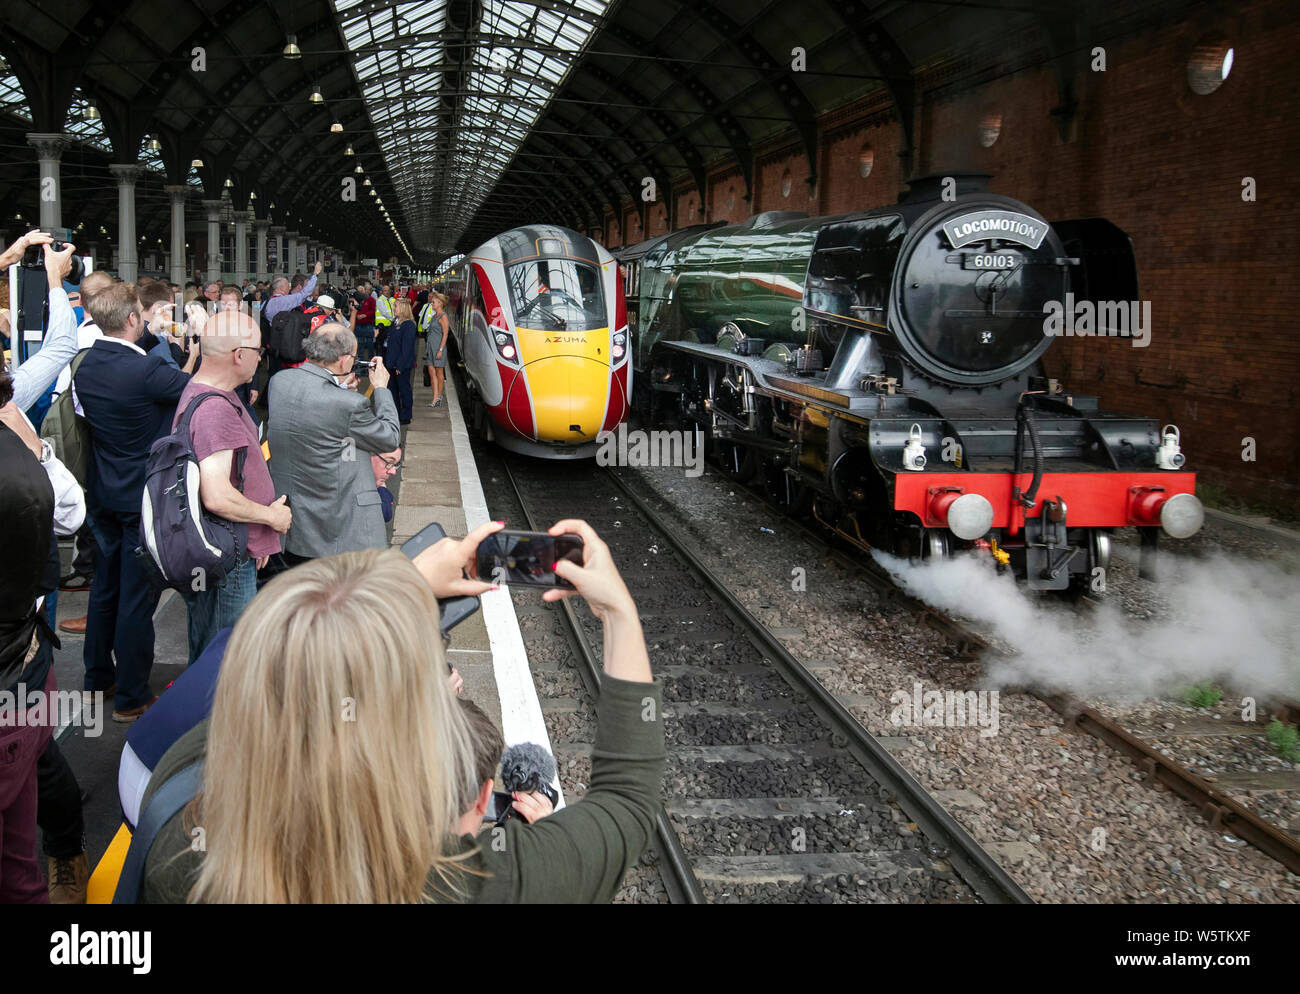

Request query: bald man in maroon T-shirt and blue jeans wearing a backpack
[{"left": 173, "top": 311, "right": 293, "bottom": 663}]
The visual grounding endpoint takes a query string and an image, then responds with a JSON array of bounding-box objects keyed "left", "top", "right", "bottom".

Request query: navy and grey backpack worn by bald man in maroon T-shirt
[{"left": 138, "top": 390, "right": 248, "bottom": 598}]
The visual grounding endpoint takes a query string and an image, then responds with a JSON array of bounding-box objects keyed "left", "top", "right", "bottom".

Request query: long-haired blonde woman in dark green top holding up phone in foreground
[{"left": 142, "top": 520, "right": 663, "bottom": 903}]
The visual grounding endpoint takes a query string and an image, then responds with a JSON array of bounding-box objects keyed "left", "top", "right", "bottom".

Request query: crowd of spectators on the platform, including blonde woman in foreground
[{"left": 0, "top": 231, "right": 663, "bottom": 903}]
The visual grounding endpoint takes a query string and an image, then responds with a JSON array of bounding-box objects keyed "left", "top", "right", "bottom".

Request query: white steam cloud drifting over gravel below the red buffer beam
[{"left": 872, "top": 547, "right": 1300, "bottom": 702}]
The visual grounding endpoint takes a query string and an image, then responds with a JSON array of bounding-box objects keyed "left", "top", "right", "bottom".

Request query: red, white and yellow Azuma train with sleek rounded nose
[{"left": 452, "top": 225, "right": 632, "bottom": 459}]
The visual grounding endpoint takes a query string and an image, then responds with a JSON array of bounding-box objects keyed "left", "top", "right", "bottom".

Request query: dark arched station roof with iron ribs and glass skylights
[{"left": 0, "top": 0, "right": 1123, "bottom": 266}]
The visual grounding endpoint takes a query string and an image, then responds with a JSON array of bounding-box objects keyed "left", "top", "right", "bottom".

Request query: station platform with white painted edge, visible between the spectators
[{"left": 42, "top": 358, "right": 550, "bottom": 883}]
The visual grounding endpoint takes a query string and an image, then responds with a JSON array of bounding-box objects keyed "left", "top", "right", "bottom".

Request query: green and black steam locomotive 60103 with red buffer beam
[{"left": 619, "top": 173, "right": 1204, "bottom": 591}]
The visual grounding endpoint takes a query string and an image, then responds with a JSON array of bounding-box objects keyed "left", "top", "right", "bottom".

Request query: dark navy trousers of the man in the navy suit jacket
[{"left": 83, "top": 508, "right": 159, "bottom": 711}]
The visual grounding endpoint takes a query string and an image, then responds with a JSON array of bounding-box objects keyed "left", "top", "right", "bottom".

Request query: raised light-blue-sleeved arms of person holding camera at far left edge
[{"left": 0, "top": 230, "right": 82, "bottom": 411}]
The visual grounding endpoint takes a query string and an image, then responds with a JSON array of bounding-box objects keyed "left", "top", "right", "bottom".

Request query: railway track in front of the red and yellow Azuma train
[{"left": 485, "top": 453, "right": 1030, "bottom": 903}]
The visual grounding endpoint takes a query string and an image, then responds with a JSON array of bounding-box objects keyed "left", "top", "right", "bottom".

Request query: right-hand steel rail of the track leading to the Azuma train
[{"left": 606, "top": 469, "right": 1034, "bottom": 904}]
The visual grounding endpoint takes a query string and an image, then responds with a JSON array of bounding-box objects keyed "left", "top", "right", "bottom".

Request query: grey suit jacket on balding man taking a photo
[{"left": 267, "top": 363, "right": 402, "bottom": 557}]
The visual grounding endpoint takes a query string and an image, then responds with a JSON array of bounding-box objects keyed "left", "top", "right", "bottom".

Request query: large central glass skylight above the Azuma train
[{"left": 338, "top": 0, "right": 610, "bottom": 255}]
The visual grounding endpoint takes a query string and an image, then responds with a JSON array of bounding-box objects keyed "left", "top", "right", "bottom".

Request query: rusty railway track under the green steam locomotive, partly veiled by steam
[{"left": 681, "top": 462, "right": 1300, "bottom": 873}]
